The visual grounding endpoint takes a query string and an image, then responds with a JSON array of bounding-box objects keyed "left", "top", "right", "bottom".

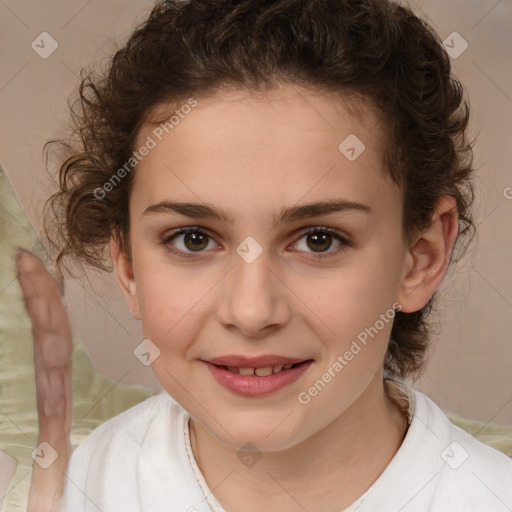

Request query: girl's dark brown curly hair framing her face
[{"left": 45, "top": 0, "right": 475, "bottom": 377}]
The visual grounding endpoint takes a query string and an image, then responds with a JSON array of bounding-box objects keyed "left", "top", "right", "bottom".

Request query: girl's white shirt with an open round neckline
[{"left": 63, "top": 381, "right": 512, "bottom": 512}]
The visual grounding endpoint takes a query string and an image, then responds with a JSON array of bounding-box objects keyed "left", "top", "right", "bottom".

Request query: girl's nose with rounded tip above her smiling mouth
[{"left": 217, "top": 242, "right": 290, "bottom": 339}]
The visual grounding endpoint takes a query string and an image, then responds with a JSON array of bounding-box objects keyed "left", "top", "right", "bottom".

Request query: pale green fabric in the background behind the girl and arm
[{"left": 0, "top": 169, "right": 512, "bottom": 512}]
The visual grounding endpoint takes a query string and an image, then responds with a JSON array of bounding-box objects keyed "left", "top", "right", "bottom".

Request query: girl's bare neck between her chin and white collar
[{"left": 190, "top": 379, "right": 407, "bottom": 512}]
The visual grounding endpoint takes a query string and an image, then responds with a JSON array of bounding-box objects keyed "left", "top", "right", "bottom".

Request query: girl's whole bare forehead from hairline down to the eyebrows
[{"left": 130, "top": 85, "right": 398, "bottom": 218}]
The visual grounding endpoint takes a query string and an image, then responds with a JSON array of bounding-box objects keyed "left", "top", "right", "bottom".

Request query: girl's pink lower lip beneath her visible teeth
[{"left": 203, "top": 360, "right": 313, "bottom": 396}]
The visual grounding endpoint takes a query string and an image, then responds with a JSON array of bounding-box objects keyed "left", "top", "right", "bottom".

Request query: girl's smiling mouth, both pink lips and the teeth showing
[{"left": 203, "top": 356, "right": 313, "bottom": 396}]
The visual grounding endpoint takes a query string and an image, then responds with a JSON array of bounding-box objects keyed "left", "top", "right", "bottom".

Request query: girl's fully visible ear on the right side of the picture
[{"left": 398, "top": 196, "right": 459, "bottom": 313}]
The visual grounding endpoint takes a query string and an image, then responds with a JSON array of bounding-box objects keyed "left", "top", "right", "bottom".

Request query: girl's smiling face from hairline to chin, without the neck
[{"left": 114, "top": 86, "right": 407, "bottom": 451}]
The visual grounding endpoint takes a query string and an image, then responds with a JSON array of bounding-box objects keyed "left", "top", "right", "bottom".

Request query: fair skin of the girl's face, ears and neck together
[{"left": 22, "top": 82, "right": 457, "bottom": 512}]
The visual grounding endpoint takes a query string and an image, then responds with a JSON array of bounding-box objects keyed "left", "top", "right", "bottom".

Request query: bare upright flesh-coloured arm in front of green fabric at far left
[{"left": 17, "top": 251, "right": 73, "bottom": 512}]
